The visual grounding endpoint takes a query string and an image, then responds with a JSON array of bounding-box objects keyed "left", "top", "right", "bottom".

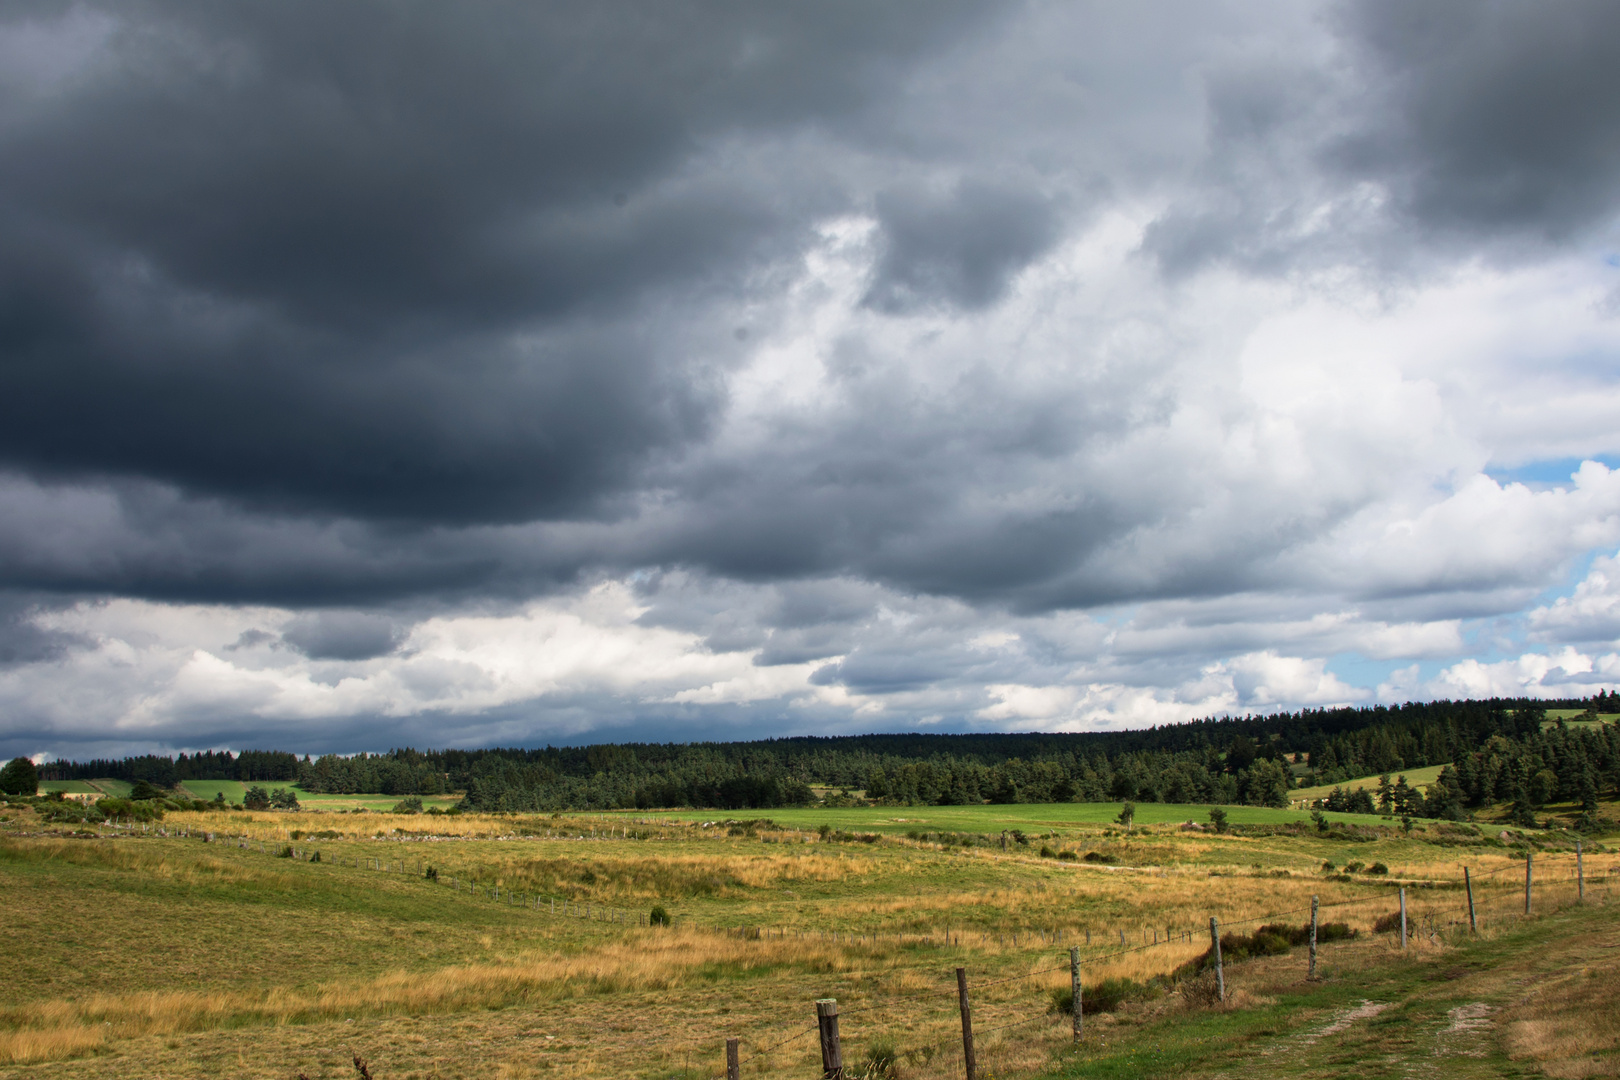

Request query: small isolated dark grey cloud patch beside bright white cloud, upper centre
[{"left": 867, "top": 183, "right": 1058, "bottom": 313}]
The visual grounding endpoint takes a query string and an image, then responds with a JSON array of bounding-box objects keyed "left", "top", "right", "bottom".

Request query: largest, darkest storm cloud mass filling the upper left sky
[{"left": 0, "top": 3, "right": 997, "bottom": 521}]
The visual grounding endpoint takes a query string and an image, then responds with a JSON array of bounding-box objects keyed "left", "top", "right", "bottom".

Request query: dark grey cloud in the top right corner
[{"left": 1340, "top": 0, "right": 1620, "bottom": 240}]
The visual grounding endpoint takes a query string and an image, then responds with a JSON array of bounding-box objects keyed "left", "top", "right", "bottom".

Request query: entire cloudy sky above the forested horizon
[{"left": 0, "top": 0, "right": 1620, "bottom": 759}]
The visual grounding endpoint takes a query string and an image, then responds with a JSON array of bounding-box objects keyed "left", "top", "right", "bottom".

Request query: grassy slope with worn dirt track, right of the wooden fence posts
[{"left": 1047, "top": 902, "right": 1620, "bottom": 1080}]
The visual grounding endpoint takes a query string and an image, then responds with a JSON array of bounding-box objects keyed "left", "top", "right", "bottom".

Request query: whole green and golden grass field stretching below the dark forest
[{"left": 0, "top": 805, "right": 1620, "bottom": 1080}]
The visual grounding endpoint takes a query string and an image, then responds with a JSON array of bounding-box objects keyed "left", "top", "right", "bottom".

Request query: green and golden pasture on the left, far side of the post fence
[{"left": 0, "top": 806, "right": 1614, "bottom": 1080}]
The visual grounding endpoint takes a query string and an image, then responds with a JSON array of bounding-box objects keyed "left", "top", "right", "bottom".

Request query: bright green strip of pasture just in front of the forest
[{"left": 638, "top": 803, "right": 1383, "bottom": 836}]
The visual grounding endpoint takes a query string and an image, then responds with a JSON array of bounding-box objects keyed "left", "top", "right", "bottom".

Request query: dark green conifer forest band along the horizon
[{"left": 31, "top": 693, "right": 1620, "bottom": 824}]
